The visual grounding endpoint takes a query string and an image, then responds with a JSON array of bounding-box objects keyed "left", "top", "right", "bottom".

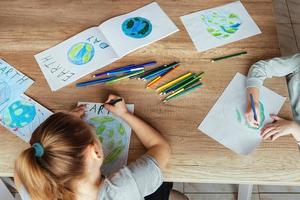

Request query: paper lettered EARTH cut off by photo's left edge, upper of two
[{"left": 0, "top": 59, "right": 34, "bottom": 111}]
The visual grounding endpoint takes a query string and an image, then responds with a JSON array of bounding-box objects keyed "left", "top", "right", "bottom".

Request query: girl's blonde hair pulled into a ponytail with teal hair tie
[{"left": 15, "top": 113, "right": 95, "bottom": 200}]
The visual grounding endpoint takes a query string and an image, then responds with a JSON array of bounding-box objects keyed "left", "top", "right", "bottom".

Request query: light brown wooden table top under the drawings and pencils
[{"left": 0, "top": 0, "right": 300, "bottom": 185}]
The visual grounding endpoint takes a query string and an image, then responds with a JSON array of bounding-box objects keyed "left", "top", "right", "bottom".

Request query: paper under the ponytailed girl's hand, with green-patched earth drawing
[{"left": 78, "top": 102, "right": 134, "bottom": 176}]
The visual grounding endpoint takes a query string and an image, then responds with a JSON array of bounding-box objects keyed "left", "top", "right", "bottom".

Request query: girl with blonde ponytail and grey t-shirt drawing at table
[{"left": 15, "top": 95, "right": 170, "bottom": 200}]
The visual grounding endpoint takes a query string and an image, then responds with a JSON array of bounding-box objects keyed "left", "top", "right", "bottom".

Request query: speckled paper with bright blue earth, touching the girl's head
[{"left": 0, "top": 94, "right": 52, "bottom": 142}]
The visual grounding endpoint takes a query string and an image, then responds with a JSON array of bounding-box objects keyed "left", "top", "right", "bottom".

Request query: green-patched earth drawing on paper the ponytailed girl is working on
[{"left": 88, "top": 116, "right": 128, "bottom": 165}]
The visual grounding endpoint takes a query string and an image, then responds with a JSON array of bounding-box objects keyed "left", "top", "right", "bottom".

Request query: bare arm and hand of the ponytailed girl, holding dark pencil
[{"left": 105, "top": 95, "right": 171, "bottom": 169}]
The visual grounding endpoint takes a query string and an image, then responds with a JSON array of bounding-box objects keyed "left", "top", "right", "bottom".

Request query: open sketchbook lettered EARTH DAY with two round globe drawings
[{"left": 35, "top": 2, "right": 178, "bottom": 91}]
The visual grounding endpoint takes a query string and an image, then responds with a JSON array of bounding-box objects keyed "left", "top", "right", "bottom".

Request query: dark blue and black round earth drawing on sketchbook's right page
[{"left": 122, "top": 17, "right": 152, "bottom": 38}]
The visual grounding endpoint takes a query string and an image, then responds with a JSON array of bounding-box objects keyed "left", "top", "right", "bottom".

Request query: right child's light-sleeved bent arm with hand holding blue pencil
[{"left": 245, "top": 53, "right": 300, "bottom": 127}]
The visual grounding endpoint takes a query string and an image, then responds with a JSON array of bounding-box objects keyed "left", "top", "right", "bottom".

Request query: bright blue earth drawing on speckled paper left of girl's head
[{"left": 3, "top": 100, "right": 36, "bottom": 128}]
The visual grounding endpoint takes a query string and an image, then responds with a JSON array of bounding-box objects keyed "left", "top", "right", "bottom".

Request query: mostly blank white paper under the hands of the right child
[{"left": 198, "top": 73, "right": 286, "bottom": 155}]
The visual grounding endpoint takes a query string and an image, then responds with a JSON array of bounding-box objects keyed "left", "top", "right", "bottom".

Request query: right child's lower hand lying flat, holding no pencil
[{"left": 261, "top": 115, "right": 300, "bottom": 141}]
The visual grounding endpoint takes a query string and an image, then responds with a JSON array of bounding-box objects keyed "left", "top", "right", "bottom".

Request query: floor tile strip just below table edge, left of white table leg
[{"left": 184, "top": 183, "right": 238, "bottom": 193}]
